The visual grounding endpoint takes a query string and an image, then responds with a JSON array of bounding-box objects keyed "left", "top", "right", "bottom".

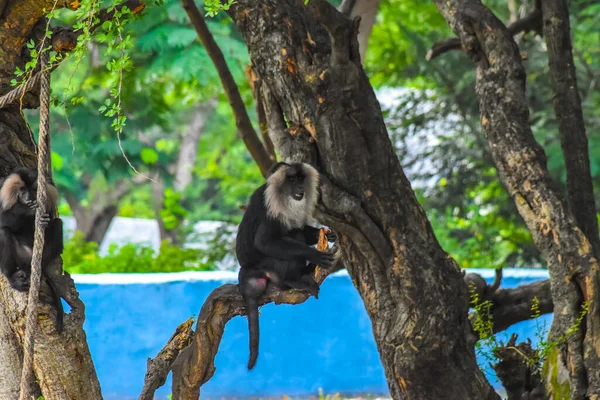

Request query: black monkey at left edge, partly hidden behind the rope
[{"left": 0, "top": 168, "right": 63, "bottom": 332}]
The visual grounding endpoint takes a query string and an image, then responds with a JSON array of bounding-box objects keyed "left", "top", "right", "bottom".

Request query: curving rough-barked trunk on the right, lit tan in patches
[{"left": 435, "top": 0, "right": 600, "bottom": 399}]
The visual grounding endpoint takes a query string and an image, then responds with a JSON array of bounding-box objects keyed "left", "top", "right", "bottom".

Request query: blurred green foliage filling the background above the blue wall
[{"left": 28, "top": 0, "right": 600, "bottom": 272}]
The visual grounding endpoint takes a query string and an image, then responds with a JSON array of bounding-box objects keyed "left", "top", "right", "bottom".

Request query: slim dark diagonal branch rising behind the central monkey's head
[{"left": 181, "top": 0, "right": 273, "bottom": 176}]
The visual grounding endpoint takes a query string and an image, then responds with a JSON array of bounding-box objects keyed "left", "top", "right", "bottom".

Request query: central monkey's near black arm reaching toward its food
[{"left": 254, "top": 223, "right": 333, "bottom": 266}]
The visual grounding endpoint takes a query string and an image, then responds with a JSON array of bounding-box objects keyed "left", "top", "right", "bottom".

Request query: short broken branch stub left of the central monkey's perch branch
[{"left": 138, "top": 318, "right": 194, "bottom": 400}]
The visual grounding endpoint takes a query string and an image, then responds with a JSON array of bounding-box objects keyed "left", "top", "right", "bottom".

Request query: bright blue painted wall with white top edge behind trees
[{"left": 74, "top": 271, "right": 551, "bottom": 400}]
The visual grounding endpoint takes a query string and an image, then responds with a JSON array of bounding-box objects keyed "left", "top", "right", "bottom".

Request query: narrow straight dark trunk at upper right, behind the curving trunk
[{"left": 542, "top": 0, "right": 600, "bottom": 250}]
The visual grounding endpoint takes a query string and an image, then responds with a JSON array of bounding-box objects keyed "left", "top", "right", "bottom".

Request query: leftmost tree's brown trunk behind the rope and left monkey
[{"left": 0, "top": 0, "right": 102, "bottom": 400}]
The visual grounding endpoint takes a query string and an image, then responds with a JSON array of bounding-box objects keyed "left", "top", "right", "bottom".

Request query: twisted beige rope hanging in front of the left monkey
[{"left": 0, "top": 53, "right": 52, "bottom": 400}]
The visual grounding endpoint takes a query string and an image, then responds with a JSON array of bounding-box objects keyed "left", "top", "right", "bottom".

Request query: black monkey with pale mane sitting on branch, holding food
[{"left": 236, "top": 162, "right": 335, "bottom": 369}]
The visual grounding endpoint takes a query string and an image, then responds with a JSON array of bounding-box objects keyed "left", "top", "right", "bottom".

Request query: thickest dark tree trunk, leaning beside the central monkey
[{"left": 230, "top": 0, "right": 497, "bottom": 400}]
